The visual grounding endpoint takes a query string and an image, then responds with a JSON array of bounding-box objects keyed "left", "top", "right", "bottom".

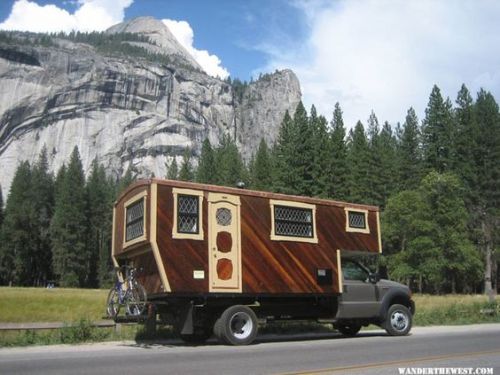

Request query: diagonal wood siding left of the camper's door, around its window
[{"left": 156, "top": 183, "right": 208, "bottom": 293}]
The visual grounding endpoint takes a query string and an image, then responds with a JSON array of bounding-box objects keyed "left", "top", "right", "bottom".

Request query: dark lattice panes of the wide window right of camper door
[{"left": 274, "top": 205, "right": 314, "bottom": 238}]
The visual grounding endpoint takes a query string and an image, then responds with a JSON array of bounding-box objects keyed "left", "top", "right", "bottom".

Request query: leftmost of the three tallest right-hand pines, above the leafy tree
[{"left": 422, "top": 86, "right": 454, "bottom": 172}]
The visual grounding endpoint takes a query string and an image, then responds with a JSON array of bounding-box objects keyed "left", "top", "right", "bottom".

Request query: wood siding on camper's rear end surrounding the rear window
[{"left": 113, "top": 181, "right": 151, "bottom": 258}]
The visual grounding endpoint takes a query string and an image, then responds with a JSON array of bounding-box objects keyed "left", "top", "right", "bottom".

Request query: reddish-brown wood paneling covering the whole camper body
[{"left": 114, "top": 180, "right": 379, "bottom": 294}]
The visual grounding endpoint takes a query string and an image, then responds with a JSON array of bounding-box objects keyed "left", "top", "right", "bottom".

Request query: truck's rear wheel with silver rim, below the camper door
[{"left": 214, "top": 305, "right": 258, "bottom": 345}]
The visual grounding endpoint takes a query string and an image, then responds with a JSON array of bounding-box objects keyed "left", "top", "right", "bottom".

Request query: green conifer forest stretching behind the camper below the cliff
[{"left": 0, "top": 86, "right": 500, "bottom": 294}]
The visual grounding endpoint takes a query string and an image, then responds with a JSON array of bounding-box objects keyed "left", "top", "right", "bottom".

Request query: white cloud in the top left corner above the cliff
[{"left": 0, "top": 0, "right": 133, "bottom": 32}]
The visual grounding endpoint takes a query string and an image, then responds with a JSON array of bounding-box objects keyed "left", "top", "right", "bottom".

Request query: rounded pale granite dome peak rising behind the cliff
[{"left": 106, "top": 17, "right": 202, "bottom": 70}]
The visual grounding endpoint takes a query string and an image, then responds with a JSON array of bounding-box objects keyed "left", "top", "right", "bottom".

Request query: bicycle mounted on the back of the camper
[{"left": 106, "top": 266, "right": 147, "bottom": 318}]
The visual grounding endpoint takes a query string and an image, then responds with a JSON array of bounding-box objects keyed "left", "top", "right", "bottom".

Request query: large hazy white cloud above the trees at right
[{"left": 260, "top": 0, "right": 500, "bottom": 127}]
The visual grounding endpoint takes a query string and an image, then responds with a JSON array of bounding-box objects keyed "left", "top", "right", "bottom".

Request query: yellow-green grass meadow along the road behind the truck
[{"left": 0, "top": 287, "right": 500, "bottom": 347}]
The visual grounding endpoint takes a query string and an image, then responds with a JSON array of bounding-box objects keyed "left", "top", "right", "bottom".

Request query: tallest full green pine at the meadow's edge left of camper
[{"left": 50, "top": 147, "right": 89, "bottom": 287}]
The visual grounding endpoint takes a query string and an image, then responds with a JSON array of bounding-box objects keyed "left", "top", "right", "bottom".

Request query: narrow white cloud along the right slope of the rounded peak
[{"left": 162, "top": 19, "right": 229, "bottom": 78}]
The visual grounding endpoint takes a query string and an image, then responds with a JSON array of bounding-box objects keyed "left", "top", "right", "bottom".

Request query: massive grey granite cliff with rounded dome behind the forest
[{"left": 0, "top": 17, "right": 301, "bottom": 196}]
